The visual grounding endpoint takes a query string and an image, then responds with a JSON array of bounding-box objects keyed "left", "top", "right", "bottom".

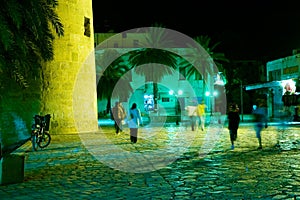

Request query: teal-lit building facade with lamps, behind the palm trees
[{"left": 94, "top": 33, "right": 226, "bottom": 116}]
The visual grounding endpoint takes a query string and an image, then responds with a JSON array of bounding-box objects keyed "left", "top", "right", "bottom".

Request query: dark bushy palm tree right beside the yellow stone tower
[{"left": 96, "top": 49, "right": 132, "bottom": 113}]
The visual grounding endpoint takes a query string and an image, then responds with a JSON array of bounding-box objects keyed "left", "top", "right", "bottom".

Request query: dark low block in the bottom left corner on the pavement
[{"left": 0, "top": 154, "right": 25, "bottom": 185}]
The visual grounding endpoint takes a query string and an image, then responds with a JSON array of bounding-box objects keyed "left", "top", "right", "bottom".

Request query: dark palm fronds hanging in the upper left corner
[{"left": 0, "top": 0, "right": 64, "bottom": 88}]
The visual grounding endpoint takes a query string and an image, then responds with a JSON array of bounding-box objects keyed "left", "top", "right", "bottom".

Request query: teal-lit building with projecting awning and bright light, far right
[{"left": 246, "top": 51, "right": 300, "bottom": 121}]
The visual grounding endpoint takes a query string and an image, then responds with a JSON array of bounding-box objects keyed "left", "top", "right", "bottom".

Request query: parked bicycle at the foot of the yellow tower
[{"left": 31, "top": 114, "right": 51, "bottom": 151}]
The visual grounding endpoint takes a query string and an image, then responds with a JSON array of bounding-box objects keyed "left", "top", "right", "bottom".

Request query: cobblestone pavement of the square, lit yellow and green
[{"left": 0, "top": 121, "right": 300, "bottom": 200}]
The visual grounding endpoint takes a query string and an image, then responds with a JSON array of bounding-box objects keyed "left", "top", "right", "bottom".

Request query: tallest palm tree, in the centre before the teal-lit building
[{"left": 129, "top": 24, "right": 177, "bottom": 110}]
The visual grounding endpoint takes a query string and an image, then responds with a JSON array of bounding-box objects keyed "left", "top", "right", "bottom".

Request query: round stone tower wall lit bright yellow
[{"left": 42, "top": 0, "right": 98, "bottom": 134}]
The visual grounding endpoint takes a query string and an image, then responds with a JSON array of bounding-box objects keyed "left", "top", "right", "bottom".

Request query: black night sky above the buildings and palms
[{"left": 93, "top": 0, "right": 300, "bottom": 60}]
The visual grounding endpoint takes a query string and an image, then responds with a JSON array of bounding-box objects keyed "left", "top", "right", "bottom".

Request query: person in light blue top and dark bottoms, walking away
[{"left": 128, "top": 103, "right": 143, "bottom": 143}]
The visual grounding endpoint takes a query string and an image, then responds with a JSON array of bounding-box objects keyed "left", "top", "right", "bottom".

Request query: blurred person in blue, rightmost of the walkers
[{"left": 253, "top": 99, "right": 268, "bottom": 149}]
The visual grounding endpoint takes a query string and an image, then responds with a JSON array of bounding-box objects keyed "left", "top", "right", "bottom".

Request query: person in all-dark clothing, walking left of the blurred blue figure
[{"left": 227, "top": 103, "right": 240, "bottom": 150}]
